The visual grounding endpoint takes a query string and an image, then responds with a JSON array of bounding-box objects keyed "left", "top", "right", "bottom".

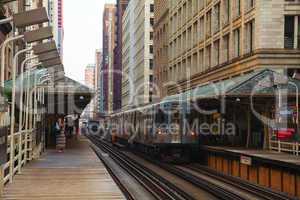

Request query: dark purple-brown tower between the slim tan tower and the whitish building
[{"left": 113, "top": 0, "right": 129, "bottom": 111}]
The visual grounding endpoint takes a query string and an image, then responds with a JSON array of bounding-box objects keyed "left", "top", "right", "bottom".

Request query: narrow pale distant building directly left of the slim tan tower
[{"left": 94, "top": 50, "right": 102, "bottom": 113}]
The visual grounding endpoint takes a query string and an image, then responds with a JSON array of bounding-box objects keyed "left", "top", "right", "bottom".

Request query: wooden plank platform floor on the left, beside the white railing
[{"left": 1, "top": 139, "right": 125, "bottom": 200}]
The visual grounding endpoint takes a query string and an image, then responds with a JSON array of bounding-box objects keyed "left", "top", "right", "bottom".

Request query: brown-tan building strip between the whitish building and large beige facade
[{"left": 153, "top": 0, "right": 172, "bottom": 98}]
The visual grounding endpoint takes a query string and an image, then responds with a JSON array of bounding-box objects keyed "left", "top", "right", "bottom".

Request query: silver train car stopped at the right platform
[{"left": 111, "top": 102, "right": 198, "bottom": 163}]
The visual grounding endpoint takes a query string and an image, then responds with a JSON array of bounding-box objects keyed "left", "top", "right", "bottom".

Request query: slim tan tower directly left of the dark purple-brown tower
[{"left": 100, "top": 4, "right": 116, "bottom": 113}]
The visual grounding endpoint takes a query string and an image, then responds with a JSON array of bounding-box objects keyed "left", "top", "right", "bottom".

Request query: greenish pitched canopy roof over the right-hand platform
[{"left": 162, "top": 69, "right": 300, "bottom": 102}]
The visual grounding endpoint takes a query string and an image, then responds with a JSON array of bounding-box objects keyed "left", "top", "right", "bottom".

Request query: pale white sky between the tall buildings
[{"left": 63, "top": 0, "right": 115, "bottom": 83}]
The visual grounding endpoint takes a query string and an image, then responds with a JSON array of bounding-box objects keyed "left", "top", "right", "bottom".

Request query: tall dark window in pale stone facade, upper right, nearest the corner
[{"left": 284, "top": 16, "right": 295, "bottom": 49}]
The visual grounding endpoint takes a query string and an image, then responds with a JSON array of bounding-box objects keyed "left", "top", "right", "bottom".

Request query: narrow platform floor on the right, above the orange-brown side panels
[{"left": 202, "top": 146, "right": 300, "bottom": 167}]
